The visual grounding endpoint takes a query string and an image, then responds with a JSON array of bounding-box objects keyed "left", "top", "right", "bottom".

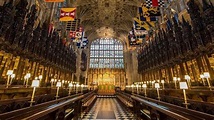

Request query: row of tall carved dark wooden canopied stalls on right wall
[{"left": 138, "top": 0, "right": 214, "bottom": 86}]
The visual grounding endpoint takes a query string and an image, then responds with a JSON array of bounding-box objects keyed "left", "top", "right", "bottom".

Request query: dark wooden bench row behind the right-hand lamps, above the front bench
[{"left": 125, "top": 89, "right": 214, "bottom": 114}]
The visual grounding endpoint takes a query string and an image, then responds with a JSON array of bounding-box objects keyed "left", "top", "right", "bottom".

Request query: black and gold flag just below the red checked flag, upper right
[{"left": 139, "top": 3, "right": 161, "bottom": 17}]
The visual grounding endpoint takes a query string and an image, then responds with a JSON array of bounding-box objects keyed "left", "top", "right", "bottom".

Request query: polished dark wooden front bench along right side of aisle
[{"left": 131, "top": 94, "right": 214, "bottom": 120}]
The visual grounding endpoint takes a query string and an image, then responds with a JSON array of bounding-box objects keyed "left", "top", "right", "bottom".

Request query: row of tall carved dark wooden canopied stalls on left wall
[{"left": 0, "top": 0, "right": 76, "bottom": 93}]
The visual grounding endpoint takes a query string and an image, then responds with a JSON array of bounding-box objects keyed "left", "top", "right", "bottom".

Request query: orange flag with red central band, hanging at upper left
[{"left": 59, "top": 8, "right": 76, "bottom": 21}]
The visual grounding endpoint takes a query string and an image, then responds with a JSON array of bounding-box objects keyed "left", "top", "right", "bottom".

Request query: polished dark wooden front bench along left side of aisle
[{"left": 0, "top": 91, "right": 96, "bottom": 120}]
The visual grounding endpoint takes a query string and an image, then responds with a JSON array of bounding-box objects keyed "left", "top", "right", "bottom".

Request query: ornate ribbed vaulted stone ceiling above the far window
[{"left": 72, "top": 0, "right": 140, "bottom": 40}]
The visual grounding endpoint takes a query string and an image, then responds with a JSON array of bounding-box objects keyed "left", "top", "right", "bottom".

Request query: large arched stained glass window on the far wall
[{"left": 90, "top": 38, "right": 124, "bottom": 68}]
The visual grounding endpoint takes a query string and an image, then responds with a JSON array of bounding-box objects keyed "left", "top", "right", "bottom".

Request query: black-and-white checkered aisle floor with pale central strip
[{"left": 81, "top": 98, "right": 134, "bottom": 120}]
